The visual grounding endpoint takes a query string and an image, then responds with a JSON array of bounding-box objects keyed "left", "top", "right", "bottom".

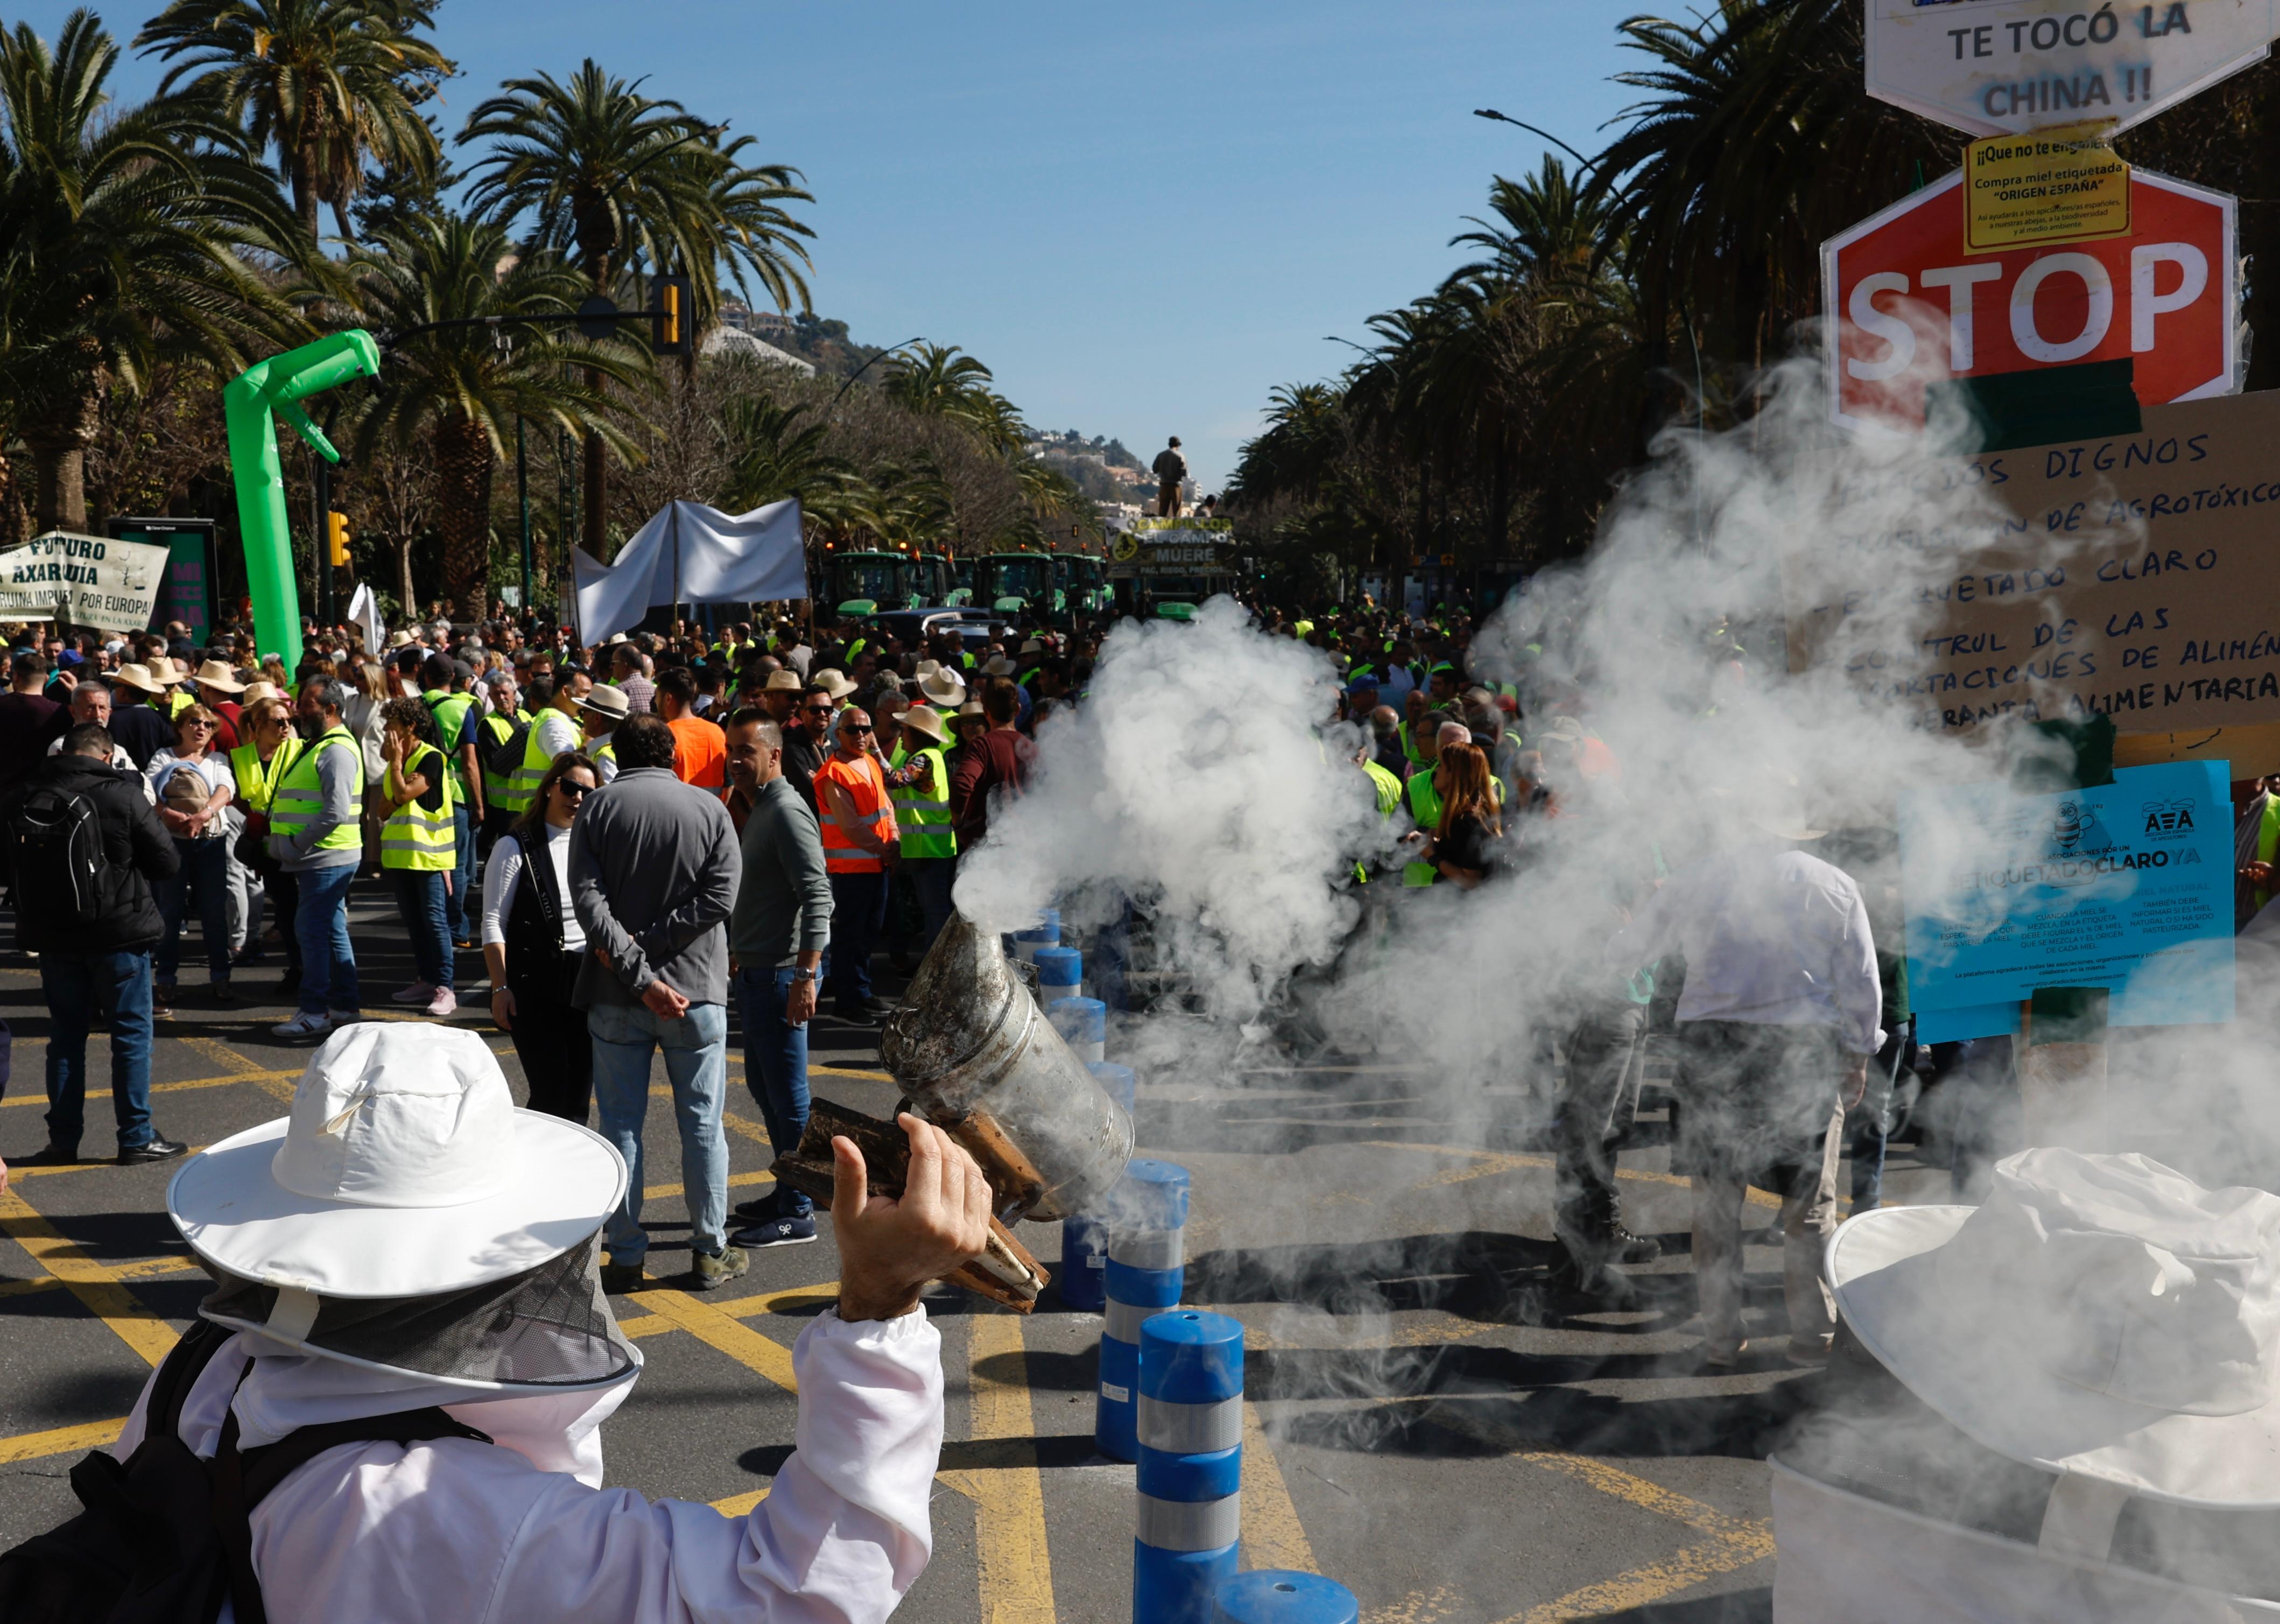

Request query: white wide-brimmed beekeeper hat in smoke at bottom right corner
[{"left": 1826, "top": 1147, "right": 2280, "bottom": 1508}]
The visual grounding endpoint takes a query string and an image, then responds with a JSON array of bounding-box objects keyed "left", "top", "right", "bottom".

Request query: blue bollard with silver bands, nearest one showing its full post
[{"left": 1133, "top": 1309, "right": 1243, "bottom": 1624}]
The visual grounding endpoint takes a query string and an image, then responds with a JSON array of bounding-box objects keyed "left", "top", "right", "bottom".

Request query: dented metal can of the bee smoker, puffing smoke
[{"left": 878, "top": 915, "right": 1133, "bottom": 1222}]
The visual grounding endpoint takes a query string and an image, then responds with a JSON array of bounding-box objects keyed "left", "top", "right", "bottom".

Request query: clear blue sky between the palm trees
[{"left": 26, "top": 0, "right": 1646, "bottom": 488}]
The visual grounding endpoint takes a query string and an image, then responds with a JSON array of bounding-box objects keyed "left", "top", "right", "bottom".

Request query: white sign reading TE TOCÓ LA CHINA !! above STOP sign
[{"left": 1865, "top": 0, "right": 2276, "bottom": 135}]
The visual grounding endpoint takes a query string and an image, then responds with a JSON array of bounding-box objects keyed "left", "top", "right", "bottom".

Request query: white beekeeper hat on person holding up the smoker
[{"left": 166, "top": 1022, "right": 625, "bottom": 1341}]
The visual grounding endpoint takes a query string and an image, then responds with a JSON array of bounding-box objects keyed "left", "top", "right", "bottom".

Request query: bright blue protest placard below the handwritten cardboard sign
[{"left": 1899, "top": 762, "right": 2232, "bottom": 1038}]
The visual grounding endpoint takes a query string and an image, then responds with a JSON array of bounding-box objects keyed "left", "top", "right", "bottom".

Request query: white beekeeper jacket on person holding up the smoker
[{"left": 118, "top": 1309, "right": 941, "bottom": 1624}]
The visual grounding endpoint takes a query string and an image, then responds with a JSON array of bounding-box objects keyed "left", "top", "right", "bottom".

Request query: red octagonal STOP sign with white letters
[{"left": 1822, "top": 171, "right": 2241, "bottom": 426}]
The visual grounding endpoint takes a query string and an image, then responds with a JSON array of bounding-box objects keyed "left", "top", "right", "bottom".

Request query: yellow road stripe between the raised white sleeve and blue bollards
[{"left": 941, "top": 1314, "right": 1055, "bottom": 1624}]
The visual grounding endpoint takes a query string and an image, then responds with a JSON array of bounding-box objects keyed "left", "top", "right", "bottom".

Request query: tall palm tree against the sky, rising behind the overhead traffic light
[{"left": 461, "top": 57, "right": 814, "bottom": 557}]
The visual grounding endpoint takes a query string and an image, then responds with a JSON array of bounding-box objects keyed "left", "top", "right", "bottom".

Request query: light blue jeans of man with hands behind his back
[{"left": 586, "top": 1003, "right": 727, "bottom": 1263}]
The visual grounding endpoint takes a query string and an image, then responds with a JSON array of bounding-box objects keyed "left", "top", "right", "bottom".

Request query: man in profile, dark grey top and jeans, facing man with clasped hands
[{"left": 727, "top": 712, "right": 832, "bottom": 1248}]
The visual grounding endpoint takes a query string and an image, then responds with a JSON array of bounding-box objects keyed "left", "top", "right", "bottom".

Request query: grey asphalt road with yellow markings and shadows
[{"left": 0, "top": 890, "right": 1940, "bottom": 1624}]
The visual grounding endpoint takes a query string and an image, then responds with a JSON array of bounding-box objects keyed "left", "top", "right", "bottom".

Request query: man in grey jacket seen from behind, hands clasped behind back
[{"left": 570, "top": 716, "right": 745, "bottom": 1291}]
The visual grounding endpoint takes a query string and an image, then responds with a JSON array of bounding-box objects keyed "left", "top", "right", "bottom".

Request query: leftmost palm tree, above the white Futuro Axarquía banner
[{"left": 0, "top": 11, "right": 292, "bottom": 529}]
